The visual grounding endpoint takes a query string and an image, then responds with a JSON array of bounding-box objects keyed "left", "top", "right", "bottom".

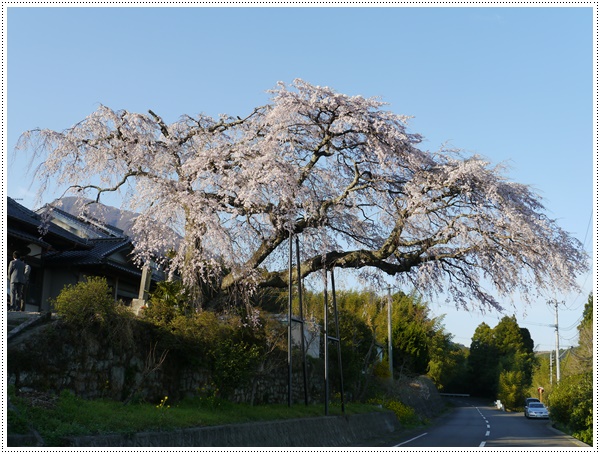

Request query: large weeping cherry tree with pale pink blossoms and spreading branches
[{"left": 17, "top": 80, "right": 587, "bottom": 309}]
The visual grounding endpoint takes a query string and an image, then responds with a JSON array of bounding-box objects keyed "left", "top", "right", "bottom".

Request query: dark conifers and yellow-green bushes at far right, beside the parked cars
[{"left": 465, "top": 294, "right": 594, "bottom": 445}]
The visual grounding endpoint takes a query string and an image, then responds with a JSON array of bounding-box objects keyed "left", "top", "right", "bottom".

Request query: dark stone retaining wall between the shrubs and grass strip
[{"left": 7, "top": 322, "right": 323, "bottom": 404}]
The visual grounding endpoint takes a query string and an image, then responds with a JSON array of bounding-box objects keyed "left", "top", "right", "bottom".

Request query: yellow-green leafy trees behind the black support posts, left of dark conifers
[{"left": 286, "top": 290, "right": 466, "bottom": 396}]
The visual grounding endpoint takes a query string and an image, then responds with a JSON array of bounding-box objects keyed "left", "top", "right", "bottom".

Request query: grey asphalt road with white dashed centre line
[{"left": 372, "top": 399, "right": 587, "bottom": 448}]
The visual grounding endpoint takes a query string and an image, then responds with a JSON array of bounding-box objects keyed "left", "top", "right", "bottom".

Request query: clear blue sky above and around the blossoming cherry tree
[{"left": 4, "top": 7, "right": 595, "bottom": 350}]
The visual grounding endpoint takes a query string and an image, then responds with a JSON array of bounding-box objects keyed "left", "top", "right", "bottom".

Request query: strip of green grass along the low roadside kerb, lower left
[{"left": 9, "top": 389, "right": 381, "bottom": 446}]
